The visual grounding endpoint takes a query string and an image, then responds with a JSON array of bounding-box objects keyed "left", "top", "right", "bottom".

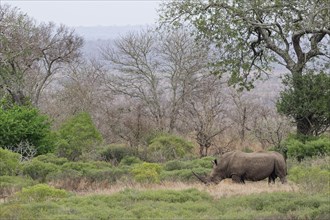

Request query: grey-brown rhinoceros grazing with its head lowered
[{"left": 193, "top": 151, "right": 287, "bottom": 184}]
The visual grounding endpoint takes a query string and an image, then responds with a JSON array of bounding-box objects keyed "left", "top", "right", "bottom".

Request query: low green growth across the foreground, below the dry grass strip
[{"left": 0, "top": 189, "right": 330, "bottom": 219}]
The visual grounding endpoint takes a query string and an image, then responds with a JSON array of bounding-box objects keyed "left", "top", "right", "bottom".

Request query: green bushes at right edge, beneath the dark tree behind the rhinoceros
[{"left": 284, "top": 136, "right": 330, "bottom": 161}]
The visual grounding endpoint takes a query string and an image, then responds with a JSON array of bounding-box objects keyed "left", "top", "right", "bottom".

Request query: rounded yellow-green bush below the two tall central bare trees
[{"left": 148, "top": 134, "right": 194, "bottom": 162}]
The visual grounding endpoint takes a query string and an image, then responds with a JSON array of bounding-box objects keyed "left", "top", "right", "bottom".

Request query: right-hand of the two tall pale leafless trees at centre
[{"left": 159, "top": 29, "right": 209, "bottom": 132}]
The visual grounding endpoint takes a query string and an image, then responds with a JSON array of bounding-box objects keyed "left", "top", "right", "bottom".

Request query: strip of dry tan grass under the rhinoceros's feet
[{"left": 77, "top": 180, "right": 299, "bottom": 199}]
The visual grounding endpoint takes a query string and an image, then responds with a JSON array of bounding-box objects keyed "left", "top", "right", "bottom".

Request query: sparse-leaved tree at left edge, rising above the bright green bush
[{"left": 0, "top": 5, "right": 83, "bottom": 106}]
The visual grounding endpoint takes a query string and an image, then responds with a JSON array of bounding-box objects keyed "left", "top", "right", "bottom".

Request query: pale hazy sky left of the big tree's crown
[{"left": 0, "top": 0, "right": 161, "bottom": 26}]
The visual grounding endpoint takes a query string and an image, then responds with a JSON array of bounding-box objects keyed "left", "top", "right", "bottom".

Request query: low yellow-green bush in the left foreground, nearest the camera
[{"left": 16, "top": 184, "right": 69, "bottom": 202}]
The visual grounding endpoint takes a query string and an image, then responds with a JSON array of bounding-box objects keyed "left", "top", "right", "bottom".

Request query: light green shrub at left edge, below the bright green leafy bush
[{"left": 0, "top": 148, "right": 21, "bottom": 176}]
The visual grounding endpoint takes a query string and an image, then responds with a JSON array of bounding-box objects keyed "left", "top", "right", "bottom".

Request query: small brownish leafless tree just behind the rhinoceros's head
[{"left": 183, "top": 75, "right": 228, "bottom": 157}]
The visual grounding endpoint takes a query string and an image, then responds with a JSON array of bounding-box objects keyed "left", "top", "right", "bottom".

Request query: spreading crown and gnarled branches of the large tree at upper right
[{"left": 160, "top": 0, "right": 330, "bottom": 133}]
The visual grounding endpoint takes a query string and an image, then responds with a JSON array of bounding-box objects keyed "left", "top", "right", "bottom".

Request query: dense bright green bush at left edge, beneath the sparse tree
[{"left": 0, "top": 105, "right": 54, "bottom": 154}]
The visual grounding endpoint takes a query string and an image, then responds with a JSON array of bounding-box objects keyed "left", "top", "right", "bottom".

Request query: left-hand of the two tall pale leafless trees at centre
[{"left": 102, "top": 30, "right": 165, "bottom": 130}]
